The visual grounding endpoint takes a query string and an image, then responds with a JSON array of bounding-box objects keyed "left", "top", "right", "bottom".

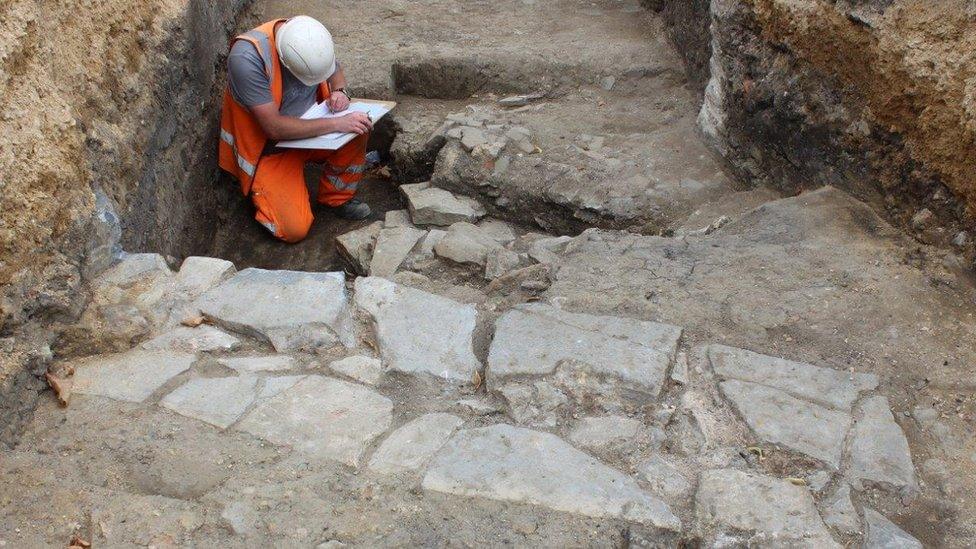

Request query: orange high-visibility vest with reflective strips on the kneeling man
[{"left": 219, "top": 19, "right": 329, "bottom": 196}]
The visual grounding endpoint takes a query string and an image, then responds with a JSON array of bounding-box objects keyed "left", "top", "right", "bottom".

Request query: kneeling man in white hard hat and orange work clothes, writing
[{"left": 220, "top": 16, "right": 373, "bottom": 242}]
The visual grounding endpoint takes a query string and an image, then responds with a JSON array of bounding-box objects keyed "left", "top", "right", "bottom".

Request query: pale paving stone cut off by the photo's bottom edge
[{"left": 695, "top": 469, "right": 841, "bottom": 549}]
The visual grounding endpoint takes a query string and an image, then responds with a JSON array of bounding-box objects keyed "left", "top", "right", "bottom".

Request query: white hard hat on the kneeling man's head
[{"left": 275, "top": 15, "right": 336, "bottom": 86}]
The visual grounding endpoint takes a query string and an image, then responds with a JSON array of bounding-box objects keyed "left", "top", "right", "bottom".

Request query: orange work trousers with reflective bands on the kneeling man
[{"left": 251, "top": 135, "right": 369, "bottom": 242}]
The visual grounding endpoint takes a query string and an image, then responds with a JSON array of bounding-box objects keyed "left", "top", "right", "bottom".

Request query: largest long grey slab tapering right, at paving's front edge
[{"left": 422, "top": 425, "right": 681, "bottom": 531}]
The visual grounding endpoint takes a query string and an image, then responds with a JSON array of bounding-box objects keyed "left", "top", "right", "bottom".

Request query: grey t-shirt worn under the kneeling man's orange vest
[{"left": 227, "top": 40, "right": 318, "bottom": 117}]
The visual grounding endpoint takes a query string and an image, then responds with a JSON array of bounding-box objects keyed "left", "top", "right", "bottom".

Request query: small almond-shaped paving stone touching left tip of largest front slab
[{"left": 369, "top": 413, "right": 463, "bottom": 475}]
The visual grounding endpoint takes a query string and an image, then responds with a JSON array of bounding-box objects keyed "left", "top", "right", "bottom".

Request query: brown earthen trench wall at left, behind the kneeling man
[{"left": 0, "top": 0, "right": 250, "bottom": 441}]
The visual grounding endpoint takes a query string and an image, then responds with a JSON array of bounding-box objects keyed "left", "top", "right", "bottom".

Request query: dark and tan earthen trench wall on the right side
[{"left": 645, "top": 0, "right": 976, "bottom": 253}]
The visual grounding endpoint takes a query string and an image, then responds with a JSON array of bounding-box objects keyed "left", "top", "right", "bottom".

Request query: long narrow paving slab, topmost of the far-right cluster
[{"left": 708, "top": 345, "right": 878, "bottom": 412}]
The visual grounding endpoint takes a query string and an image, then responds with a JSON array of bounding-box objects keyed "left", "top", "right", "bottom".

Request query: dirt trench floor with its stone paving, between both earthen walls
[{"left": 0, "top": 0, "right": 976, "bottom": 548}]
